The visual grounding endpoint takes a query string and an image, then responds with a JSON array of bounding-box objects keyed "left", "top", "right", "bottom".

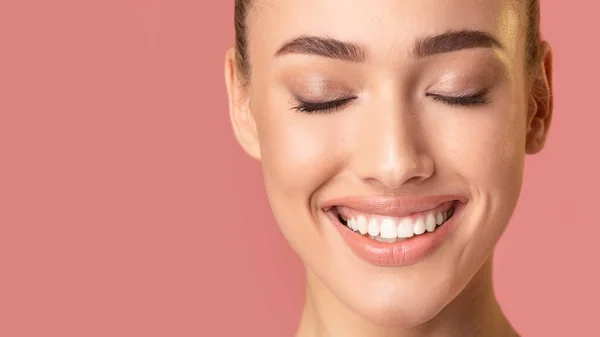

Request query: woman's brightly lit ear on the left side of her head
[{"left": 225, "top": 48, "right": 260, "bottom": 160}]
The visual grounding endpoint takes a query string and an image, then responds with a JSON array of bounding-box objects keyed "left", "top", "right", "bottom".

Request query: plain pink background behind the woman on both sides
[{"left": 0, "top": 0, "right": 600, "bottom": 337}]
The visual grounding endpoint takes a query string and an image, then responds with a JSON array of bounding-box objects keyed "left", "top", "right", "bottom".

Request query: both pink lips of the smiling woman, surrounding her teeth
[{"left": 323, "top": 196, "right": 466, "bottom": 267}]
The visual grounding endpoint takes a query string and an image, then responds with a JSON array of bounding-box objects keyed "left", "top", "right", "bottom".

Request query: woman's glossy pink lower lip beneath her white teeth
[{"left": 326, "top": 202, "right": 464, "bottom": 267}]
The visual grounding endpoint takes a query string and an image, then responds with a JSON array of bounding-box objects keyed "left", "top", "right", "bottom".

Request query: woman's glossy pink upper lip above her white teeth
[{"left": 322, "top": 194, "right": 467, "bottom": 217}]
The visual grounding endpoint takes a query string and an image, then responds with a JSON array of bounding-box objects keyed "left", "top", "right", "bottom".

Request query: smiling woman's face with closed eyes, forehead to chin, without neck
[{"left": 230, "top": 0, "right": 547, "bottom": 326}]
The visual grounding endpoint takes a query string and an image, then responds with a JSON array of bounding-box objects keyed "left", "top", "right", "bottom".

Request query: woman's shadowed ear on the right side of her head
[{"left": 526, "top": 41, "right": 554, "bottom": 154}]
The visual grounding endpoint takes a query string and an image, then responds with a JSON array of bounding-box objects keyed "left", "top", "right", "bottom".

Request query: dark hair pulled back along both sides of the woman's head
[{"left": 234, "top": 0, "right": 541, "bottom": 83}]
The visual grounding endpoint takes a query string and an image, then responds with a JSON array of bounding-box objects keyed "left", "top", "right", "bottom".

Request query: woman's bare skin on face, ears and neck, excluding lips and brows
[{"left": 225, "top": 0, "right": 552, "bottom": 337}]
